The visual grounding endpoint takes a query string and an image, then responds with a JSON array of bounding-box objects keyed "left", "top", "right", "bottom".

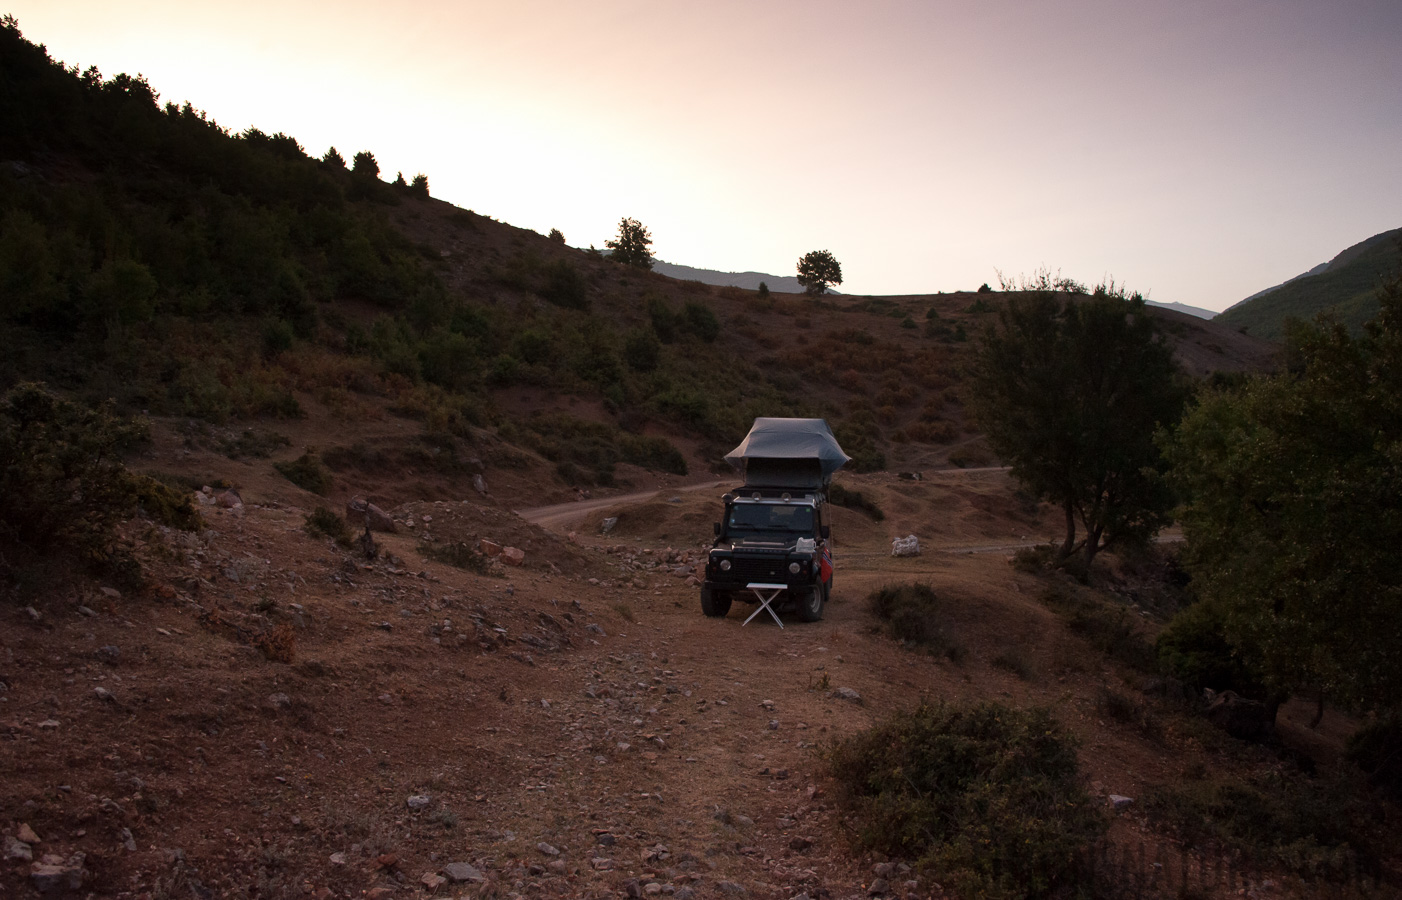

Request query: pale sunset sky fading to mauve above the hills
[{"left": 10, "top": 0, "right": 1402, "bottom": 310}]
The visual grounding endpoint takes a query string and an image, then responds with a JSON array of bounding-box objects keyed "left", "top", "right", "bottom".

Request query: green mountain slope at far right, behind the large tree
[{"left": 1213, "top": 229, "right": 1402, "bottom": 341}]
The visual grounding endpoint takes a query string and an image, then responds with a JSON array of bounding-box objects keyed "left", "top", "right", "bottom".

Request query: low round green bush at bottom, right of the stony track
[{"left": 826, "top": 702, "right": 1106, "bottom": 897}]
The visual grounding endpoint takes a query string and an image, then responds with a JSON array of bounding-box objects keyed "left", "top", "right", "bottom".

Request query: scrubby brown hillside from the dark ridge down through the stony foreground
[{"left": 10, "top": 27, "right": 1402, "bottom": 900}]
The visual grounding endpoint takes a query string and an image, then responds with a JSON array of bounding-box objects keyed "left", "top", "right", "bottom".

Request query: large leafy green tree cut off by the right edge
[{"left": 1166, "top": 266, "right": 1402, "bottom": 712}]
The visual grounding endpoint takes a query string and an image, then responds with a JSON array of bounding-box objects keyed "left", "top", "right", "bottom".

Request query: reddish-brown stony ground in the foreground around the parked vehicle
[{"left": 0, "top": 454, "right": 1379, "bottom": 900}]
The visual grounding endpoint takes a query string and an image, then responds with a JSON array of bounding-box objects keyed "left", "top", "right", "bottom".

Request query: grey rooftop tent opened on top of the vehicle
[{"left": 725, "top": 419, "right": 851, "bottom": 489}]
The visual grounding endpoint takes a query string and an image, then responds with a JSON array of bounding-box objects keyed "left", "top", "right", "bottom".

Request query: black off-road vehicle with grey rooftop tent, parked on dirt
[{"left": 701, "top": 419, "right": 848, "bottom": 622}]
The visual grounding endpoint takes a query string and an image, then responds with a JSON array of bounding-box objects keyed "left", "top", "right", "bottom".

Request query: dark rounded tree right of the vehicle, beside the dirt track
[{"left": 972, "top": 286, "right": 1185, "bottom": 572}]
